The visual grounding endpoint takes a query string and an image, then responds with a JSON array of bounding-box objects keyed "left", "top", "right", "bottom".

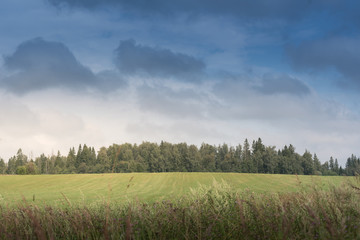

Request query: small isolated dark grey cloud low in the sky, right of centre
[{"left": 254, "top": 74, "right": 310, "bottom": 96}]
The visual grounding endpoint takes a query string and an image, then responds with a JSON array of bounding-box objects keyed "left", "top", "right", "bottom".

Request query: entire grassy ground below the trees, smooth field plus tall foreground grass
[{"left": 0, "top": 173, "right": 360, "bottom": 240}]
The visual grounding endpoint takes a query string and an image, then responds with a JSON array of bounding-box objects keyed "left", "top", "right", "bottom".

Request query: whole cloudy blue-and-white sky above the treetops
[{"left": 0, "top": 0, "right": 360, "bottom": 166}]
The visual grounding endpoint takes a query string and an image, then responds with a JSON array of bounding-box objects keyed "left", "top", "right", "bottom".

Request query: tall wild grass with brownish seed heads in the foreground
[{"left": 0, "top": 177, "right": 360, "bottom": 239}]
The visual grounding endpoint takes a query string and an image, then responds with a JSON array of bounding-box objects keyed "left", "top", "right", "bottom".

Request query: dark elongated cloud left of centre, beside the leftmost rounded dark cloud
[{"left": 115, "top": 40, "right": 205, "bottom": 81}]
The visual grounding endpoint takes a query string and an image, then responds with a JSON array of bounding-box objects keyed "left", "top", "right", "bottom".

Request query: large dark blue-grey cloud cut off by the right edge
[{"left": 287, "top": 37, "right": 360, "bottom": 87}]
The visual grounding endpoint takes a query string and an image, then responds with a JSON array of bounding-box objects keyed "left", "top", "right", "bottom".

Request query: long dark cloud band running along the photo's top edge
[{"left": 48, "top": 0, "right": 339, "bottom": 19}]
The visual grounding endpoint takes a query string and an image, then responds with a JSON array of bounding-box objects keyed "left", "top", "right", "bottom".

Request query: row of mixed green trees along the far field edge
[{"left": 0, "top": 138, "right": 360, "bottom": 176}]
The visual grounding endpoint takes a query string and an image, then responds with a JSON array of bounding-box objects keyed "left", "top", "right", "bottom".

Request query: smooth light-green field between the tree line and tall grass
[{"left": 0, "top": 173, "right": 349, "bottom": 205}]
